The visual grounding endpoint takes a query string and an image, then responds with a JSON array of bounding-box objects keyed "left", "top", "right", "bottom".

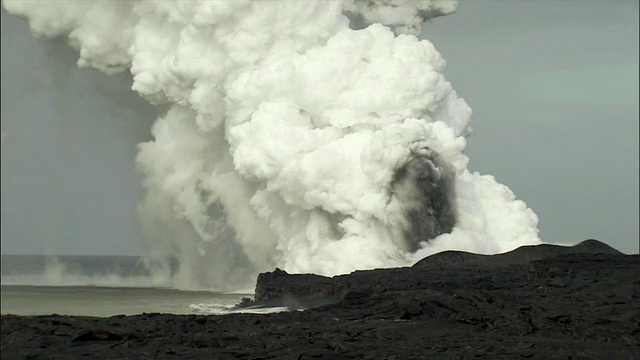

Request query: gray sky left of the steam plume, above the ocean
[{"left": 1, "top": 8, "right": 156, "bottom": 255}]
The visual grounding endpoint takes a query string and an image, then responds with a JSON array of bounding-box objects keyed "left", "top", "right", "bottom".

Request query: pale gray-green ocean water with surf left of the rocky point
[{"left": 0, "top": 255, "right": 258, "bottom": 317}]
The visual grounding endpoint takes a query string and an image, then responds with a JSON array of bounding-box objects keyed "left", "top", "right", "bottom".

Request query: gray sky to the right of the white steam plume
[{"left": 424, "top": 0, "right": 639, "bottom": 253}]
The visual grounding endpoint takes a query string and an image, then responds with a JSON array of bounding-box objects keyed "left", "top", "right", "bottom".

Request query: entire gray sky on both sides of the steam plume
[{"left": 1, "top": 1, "right": 639, "bottom": 255}]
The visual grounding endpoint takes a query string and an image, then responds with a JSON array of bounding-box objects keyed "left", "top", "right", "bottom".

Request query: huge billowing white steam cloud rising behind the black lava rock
[{"left": 4, "top": 0, "right": 540, "bottom": 289}]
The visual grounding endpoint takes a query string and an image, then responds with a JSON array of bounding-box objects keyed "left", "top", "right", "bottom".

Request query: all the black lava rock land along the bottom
[{"left": 0, "top": 240, "right": 640, "bottom": 359}]
